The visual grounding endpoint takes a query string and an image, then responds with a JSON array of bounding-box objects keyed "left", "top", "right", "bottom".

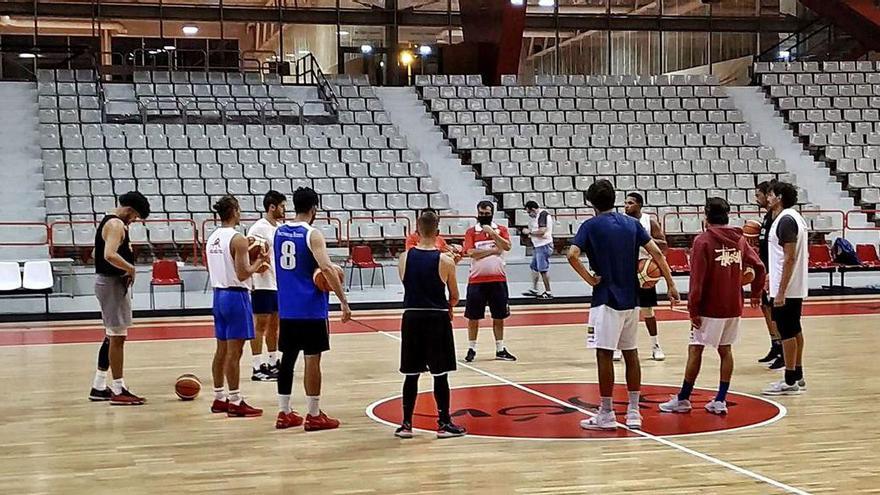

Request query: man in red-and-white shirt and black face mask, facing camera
[{"left": 462, "top": 201, "right": 516, "bottom": 363}]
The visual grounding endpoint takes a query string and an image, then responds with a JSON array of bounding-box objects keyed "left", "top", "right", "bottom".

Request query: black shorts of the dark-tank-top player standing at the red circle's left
[{"left": 400, "top": 311, "right": 456, "bottom": 375}]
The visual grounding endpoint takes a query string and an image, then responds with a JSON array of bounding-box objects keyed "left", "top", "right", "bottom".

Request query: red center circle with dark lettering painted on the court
[{"left": 367, "top": 380, "right": 785, "bottom": 439}]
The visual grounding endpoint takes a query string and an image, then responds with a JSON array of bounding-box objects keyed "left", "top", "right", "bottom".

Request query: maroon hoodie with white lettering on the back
[{"left": 688, "top": 225, "right": 766, "bottom": 318}]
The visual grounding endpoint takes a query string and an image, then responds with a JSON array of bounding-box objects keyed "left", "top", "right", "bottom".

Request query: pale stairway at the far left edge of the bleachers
[{"left": 0, "top": 82, "right": 48, "bottom": 259}]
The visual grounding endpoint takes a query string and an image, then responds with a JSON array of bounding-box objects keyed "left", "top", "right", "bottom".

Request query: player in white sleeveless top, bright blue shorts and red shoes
[{"left": 205, "top": 196, "right": 267, "bottom": 418}]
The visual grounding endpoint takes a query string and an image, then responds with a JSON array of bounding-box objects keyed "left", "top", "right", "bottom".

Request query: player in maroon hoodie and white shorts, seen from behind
[{"left": 660, "top": 198, "right": 766, "bottom": 414}]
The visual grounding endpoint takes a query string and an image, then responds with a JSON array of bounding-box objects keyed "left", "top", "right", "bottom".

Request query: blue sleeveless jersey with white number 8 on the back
[{"left": 275, "top": 222, "right": 330, "bottom": 320}]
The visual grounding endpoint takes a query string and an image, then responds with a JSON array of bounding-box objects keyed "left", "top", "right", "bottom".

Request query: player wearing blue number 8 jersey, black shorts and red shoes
[{"left": 275, "top": 187, "right": 351, "bottom": 431}]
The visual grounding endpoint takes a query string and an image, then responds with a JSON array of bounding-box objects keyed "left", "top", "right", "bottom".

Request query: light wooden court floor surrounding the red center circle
[{"left": 0, "top": 300, "right": 880, "bottom": 495}]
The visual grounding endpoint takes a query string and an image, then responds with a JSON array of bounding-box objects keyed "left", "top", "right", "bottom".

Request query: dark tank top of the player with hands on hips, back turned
[{"left": 403, "top": 248, "right": 449, "bottom": 311}]
